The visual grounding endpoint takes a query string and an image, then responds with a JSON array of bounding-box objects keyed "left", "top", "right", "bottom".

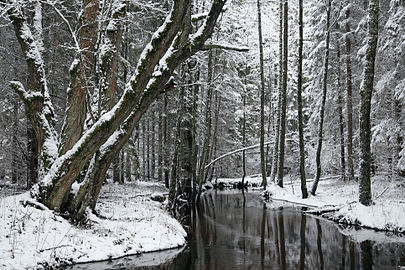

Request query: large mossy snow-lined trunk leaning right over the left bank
[{"left": 37, "top": 0, "right": 225, "bottom": 210}]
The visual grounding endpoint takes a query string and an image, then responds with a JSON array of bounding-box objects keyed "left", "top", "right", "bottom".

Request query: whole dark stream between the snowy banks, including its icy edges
[{"left": 74, "top": 191, "right": 405, "bottom": 270}]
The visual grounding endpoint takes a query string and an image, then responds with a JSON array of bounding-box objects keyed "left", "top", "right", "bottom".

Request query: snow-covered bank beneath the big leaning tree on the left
[{"left": 0, "top": 182, "right": 186, "bottom": 269}]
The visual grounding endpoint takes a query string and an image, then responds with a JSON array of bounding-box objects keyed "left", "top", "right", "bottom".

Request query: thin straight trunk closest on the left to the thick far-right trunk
[{"left": 345, "top": 8, "right": 354, "bottom": 181}]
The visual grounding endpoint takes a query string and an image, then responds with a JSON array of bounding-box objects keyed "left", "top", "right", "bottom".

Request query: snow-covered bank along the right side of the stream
[{"left": 217, "top": 175, "right": 405, "bottom": 233}]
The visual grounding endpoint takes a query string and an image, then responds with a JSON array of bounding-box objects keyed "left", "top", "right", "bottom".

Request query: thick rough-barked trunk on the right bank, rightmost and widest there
[{"left": 359, "top": 0, "right": 379, "bottom": 206}]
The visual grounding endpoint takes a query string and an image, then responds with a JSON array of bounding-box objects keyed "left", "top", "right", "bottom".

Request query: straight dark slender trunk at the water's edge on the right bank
[{"left": 297, "top": 0, "right": 308, "bottom": 199}]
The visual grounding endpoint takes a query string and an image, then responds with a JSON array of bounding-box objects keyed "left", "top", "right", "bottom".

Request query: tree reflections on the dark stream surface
[{"left": 185, "top": 192, "right": 405, "bottom": 269}]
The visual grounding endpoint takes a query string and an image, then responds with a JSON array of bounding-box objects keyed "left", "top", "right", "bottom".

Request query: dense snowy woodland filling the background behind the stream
[{"left": 0, "top": 0, "right": 405, "bottom": 209}]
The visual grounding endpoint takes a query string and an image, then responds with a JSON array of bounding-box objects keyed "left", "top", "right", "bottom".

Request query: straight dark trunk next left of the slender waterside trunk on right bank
[{"left": 277, "top": 0, "right": 288, "bottom": 187}]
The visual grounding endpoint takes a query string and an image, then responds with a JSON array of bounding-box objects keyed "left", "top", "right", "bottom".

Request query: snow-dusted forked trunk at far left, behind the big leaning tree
[{"left": 8, "top": 2, "right": 57, "bottom": 179}]
